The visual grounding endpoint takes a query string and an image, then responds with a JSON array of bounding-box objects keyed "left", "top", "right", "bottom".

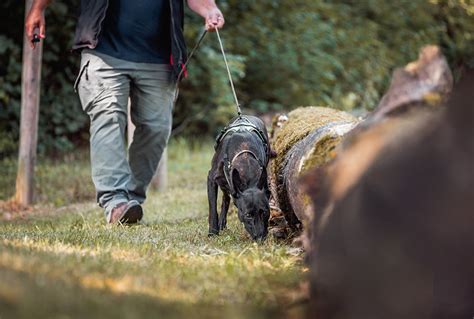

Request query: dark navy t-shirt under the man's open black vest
[{"left": 95, "top": 0, "right": 171, "bottom": 64}]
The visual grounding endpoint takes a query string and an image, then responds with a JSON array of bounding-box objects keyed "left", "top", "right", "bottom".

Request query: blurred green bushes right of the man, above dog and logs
[{"left": 176, "top": 0, "right": 474, "bottom": 134}]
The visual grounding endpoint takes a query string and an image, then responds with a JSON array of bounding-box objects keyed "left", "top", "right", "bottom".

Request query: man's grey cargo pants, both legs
[{"left": 74, "top": 50, "right": 175, "bottom": 218}]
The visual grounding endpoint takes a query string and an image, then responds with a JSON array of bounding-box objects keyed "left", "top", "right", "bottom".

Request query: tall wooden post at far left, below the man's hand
[{"left": 15, "top": 0, "right": 43, "bottom": 206}]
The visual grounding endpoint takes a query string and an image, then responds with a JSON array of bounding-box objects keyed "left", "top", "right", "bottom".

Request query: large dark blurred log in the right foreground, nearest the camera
[{"left": 306, "top": 67, "right": 474, "bottom": 319}]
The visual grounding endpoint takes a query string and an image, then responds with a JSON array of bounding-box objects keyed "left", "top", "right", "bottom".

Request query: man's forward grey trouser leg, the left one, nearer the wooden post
[{"left": 76, "top": 51, "right": 135, "bottom": 221}]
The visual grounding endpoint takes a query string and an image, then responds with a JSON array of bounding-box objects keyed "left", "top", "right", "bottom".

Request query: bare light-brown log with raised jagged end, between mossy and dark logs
[{"left": 312, "top": 46, "right": 453, "bottom": 220}]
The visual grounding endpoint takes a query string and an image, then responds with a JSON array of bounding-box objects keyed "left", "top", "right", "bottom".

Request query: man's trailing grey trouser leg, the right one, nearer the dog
[{"left": 128, "top": 64, "right": 175, "bottom": 203}]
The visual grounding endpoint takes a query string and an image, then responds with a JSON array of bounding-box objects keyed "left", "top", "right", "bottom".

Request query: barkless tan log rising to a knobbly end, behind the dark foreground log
[{"left": 301, "top": 46, "right": 453, "bottom": 251}]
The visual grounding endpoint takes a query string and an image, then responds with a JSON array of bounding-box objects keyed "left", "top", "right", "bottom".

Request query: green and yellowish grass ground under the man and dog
[{"left": 0, "top": 140, "right": 305, "bottom": 318}]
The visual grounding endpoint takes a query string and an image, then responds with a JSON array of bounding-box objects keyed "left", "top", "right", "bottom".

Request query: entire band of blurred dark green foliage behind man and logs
[{"left": 0, "top": 0, "right": 474, "bottom": 158}]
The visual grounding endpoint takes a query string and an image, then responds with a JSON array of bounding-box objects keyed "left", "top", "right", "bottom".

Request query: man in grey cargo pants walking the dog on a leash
[{"left": 25, "top": 0, "right": 224, "bottom": 223}]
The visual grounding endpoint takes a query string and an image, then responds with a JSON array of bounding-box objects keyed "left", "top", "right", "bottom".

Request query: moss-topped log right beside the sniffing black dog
[{"left": 271, "top": 107, "right": 357, "bottom": 229}]
